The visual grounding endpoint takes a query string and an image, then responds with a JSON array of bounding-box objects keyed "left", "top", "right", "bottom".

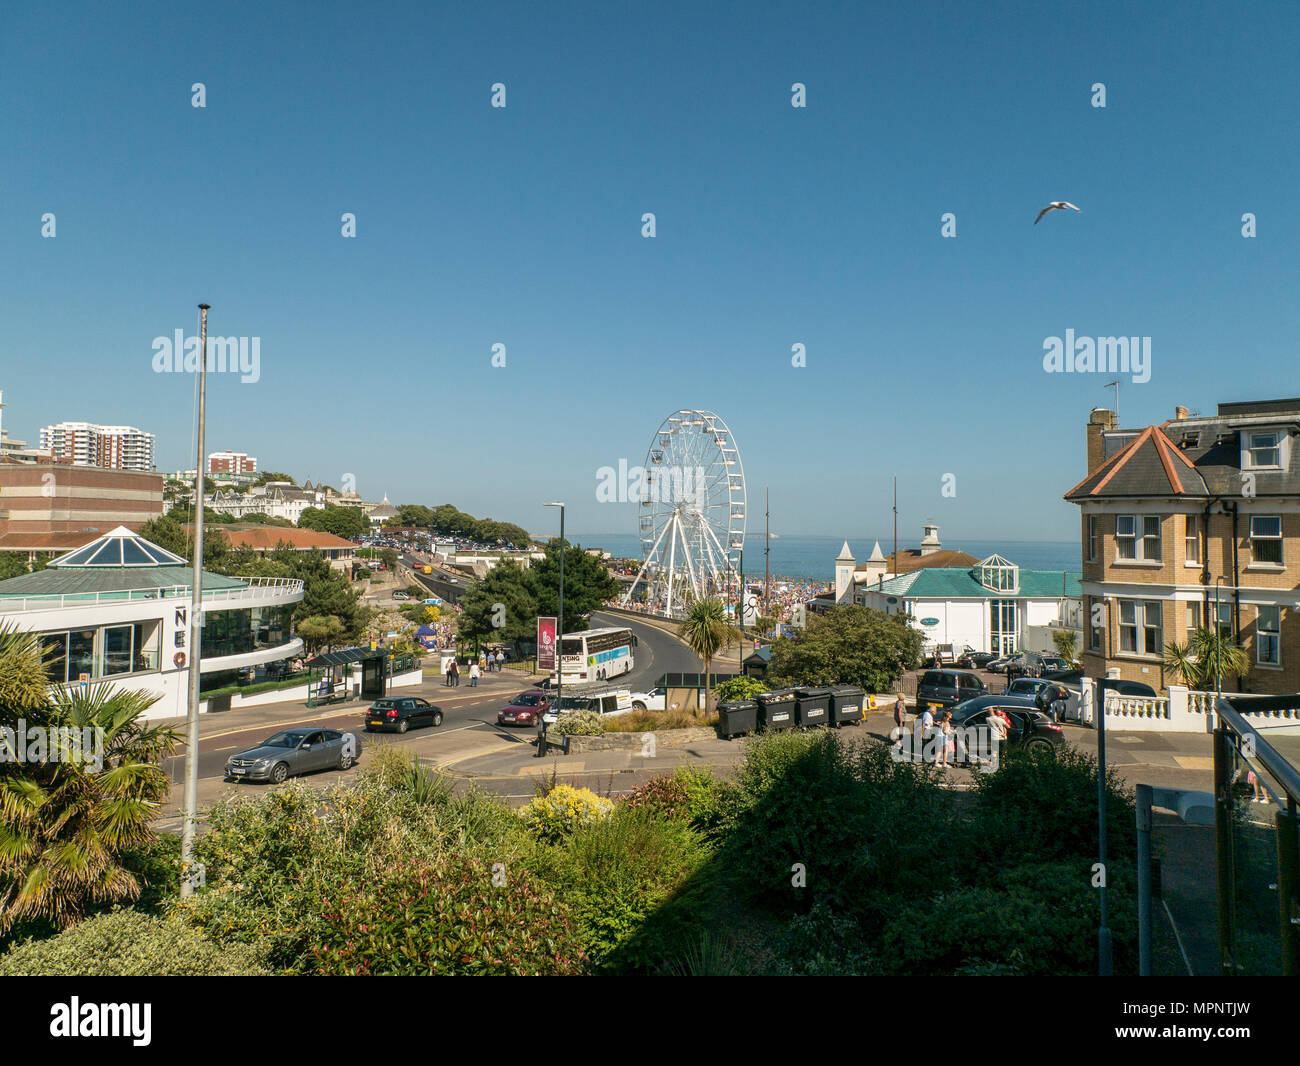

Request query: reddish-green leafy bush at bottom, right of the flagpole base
[{"left": 303, "top": 857, "right": 585, "bottom": 976}]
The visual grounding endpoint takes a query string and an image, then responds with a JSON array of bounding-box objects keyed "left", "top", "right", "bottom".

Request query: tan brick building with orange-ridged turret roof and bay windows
[{"left": 1065, "top": 399, "right": 1300, "bottom": 694}]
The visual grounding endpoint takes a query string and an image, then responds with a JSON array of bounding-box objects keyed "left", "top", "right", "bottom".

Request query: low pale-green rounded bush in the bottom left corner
[{"left": 0, "top": 910, "right": 268, "bottom": 978}]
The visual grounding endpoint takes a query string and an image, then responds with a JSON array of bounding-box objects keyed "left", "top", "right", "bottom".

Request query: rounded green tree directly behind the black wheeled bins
[{"left": 767, "top": 605, "right": 920, "bottom": 693}]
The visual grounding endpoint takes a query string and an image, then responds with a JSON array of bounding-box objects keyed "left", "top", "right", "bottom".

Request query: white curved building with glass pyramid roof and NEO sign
[{"left": 0, "top": 527, "right": 303, "bottom": 719}]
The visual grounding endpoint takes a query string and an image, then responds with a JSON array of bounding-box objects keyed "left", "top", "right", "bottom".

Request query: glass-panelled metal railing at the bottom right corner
[{"left": 1214, "top": 694, "right": 1300, "bottom": 976}]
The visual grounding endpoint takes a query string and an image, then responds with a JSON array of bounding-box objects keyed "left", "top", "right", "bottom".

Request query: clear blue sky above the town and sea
[{"left": 0, "top": 3, "right": 1300, "bottom": 543}]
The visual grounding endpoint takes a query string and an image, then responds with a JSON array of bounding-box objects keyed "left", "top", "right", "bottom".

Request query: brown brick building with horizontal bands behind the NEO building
[{"left": 0, "top": 464, "right": 164, "bottom": 560}]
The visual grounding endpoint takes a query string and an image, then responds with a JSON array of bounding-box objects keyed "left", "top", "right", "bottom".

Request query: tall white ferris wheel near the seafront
[{"left": 623, "top": 411, "right": 745, "bottom": 616}]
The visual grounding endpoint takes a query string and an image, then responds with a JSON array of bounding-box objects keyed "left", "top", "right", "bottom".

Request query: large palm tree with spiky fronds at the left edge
[{"left": 0, "top": 633, "right": 178, "bottom": 935}]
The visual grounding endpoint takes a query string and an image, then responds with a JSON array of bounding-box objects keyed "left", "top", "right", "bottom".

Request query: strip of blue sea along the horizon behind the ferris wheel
[{"left": 569, "top": 533, "right": 1082, "bottom": 581}]
